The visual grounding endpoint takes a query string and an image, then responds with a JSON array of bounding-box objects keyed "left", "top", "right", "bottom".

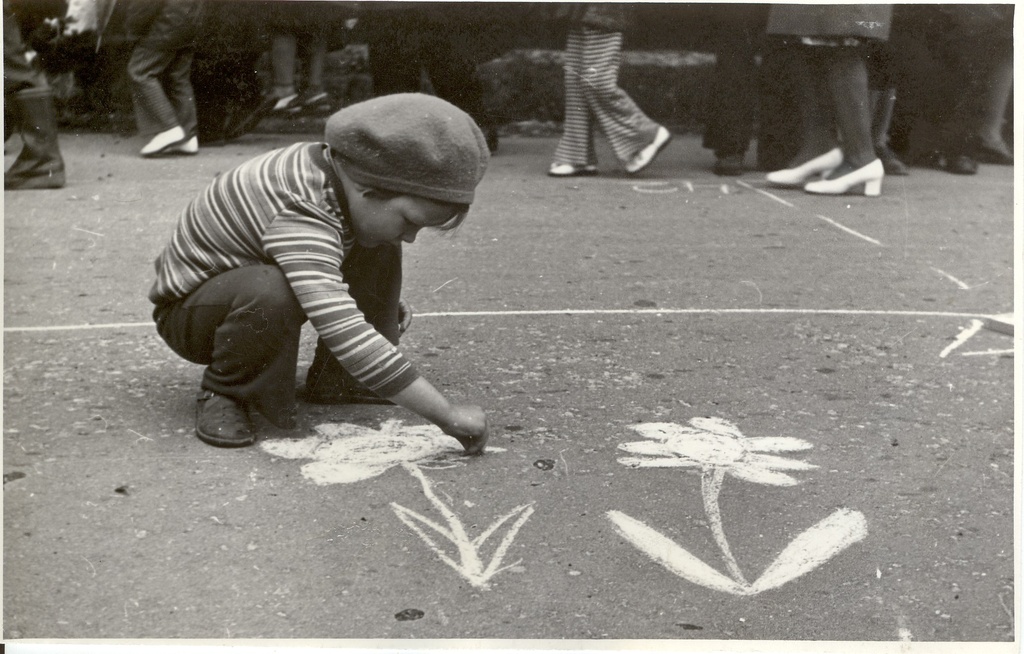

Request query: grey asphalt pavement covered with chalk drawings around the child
[{"left": 3, "top": 134, "right": 1019, "bottom": 652}]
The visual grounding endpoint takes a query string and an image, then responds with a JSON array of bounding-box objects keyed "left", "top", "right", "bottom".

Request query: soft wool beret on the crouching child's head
[{"left": 325, "top": 93, "right": 490, "bottom": 205}]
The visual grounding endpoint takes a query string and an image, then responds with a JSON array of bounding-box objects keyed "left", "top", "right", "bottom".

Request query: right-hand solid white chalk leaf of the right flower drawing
[{"left": 751, "top": 509, "right": 867, "bottom": 594}]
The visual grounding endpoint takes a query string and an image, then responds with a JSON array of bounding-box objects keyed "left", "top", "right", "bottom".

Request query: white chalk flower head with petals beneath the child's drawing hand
[{"left": 260, "top": 420, "right": 505, "bottom": 485}]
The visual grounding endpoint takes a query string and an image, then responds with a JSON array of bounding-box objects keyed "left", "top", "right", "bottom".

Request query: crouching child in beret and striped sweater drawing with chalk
[{"left": 150, "top": 93, "right": 488, "bottom": 454}]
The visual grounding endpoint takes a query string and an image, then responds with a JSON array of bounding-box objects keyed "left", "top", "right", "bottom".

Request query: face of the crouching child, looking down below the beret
[{"left": 348, "top": 190, "right": 455, "bottom": 248}]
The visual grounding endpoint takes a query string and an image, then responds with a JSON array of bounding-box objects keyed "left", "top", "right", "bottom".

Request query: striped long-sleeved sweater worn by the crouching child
[{"left": 148, "top": 143, "right": 419, "bottom": 397}]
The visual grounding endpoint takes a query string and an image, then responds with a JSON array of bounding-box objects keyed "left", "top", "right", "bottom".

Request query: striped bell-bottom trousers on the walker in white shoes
[{"left": 554, "top": 28, "right": 658, "bottom": 166}]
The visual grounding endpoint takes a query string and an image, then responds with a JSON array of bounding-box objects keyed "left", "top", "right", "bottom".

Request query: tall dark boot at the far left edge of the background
[{"left": 3, "top": 88, "right": 65, "bottom": 189}]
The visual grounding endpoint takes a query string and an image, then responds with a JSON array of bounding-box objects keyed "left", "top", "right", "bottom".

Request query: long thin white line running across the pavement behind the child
[{"left": 3, "top": 309, "right": 999, "bottom": 334}]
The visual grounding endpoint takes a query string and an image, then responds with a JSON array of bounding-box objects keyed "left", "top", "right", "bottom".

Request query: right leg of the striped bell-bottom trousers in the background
[{"left": 583, "top": 28, "right": 658, "bottom": 162}]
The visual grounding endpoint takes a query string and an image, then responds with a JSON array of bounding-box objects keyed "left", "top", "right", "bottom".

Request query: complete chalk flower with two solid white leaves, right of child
[{"left": 607, "top": 418, "right": 867, "bottom": 595}]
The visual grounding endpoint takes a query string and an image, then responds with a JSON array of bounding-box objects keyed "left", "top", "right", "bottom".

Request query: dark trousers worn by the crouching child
[{"left": 153, "top": 245, "right": 401, "bottom": 427}]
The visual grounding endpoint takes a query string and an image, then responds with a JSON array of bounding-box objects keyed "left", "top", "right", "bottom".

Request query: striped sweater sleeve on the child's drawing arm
[{"left": 263, "top": 204, "right": 419, "bottom": 397}]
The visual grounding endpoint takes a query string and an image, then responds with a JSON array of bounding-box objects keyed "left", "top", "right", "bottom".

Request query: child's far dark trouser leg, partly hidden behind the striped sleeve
[{"left": 306, "top": 244, "right": 401, "bottom": 390}]
